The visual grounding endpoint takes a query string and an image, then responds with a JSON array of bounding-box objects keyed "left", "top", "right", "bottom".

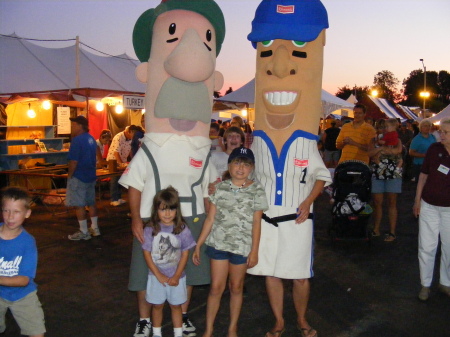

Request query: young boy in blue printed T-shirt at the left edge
[{"left": 0, "top": 187, "right": 45, "bottom": 337}]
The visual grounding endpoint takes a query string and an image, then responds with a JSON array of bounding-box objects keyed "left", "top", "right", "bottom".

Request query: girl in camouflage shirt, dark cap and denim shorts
[{"left": 192, "top": 147, "right": 268, "bottom": 337}]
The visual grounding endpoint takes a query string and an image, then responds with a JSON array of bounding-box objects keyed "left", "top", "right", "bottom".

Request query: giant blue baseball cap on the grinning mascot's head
[{"left": 247, "top": 0, "right": 329, "bottom": 48}]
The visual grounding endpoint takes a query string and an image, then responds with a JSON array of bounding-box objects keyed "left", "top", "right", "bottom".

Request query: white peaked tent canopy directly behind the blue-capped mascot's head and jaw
[{"left": 216, "top": 79, "right": 353, "bottom": 117}]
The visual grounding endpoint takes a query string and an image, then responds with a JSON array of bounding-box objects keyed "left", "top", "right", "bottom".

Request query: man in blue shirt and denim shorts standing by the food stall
[{"left": 66, "top": 116, "right": 100, "bottom": 241}]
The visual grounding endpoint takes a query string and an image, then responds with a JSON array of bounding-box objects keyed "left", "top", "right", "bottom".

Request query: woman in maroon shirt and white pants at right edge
[{"left": 413, "top": 118, "right": 450, "bottom": 301}]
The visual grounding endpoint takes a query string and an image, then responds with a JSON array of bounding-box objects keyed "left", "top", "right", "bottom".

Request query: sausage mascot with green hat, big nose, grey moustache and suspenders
[{"left": 120, "top": 0, "right": 225, "bottom": 336}]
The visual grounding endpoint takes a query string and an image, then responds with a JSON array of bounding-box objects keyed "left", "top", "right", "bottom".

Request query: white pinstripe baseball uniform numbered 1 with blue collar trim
[{"left": 248, "top": 130, "right": 332, "bottom": 279}]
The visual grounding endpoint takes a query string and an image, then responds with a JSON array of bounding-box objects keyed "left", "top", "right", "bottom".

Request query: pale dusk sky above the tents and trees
[{"left": 0, "top": 0, "right": 450, "bottom": 94}]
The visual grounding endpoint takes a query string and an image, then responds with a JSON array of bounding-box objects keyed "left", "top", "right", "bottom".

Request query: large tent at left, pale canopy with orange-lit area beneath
[{"left": 0, "top": 34, "right": 145, "bottom": 137}]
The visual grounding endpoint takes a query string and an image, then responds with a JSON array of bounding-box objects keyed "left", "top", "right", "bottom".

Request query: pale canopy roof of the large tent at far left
[{"left": 0, "top": 35, "right": 145, "bottom": 94}]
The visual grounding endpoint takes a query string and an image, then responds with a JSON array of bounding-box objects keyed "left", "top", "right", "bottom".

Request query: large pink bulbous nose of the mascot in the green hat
[{"left": 164, "top": 28, "right": 216, "bottom": 82}]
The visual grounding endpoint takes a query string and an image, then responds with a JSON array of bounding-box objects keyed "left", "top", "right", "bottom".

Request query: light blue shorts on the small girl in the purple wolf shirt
[{"left": 145, "top": 275, "right": 187, "bottom": 305}]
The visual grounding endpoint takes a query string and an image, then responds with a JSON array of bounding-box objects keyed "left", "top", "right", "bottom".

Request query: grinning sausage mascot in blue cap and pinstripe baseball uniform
[{"left": 244, "top": 0, "right": 331, "bottom": 337}]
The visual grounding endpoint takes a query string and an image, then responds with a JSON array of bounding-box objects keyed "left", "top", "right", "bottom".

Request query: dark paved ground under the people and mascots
[{"left": 4, "top": 182, "right": 450, "bottom": 337}]
